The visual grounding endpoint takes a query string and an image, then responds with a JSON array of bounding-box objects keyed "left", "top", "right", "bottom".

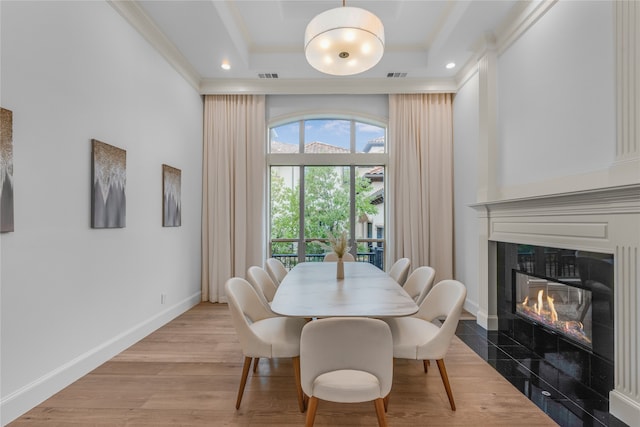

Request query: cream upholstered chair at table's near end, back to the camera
[{"left": 300, "top": 317, "right": 393, "bottom": 427}]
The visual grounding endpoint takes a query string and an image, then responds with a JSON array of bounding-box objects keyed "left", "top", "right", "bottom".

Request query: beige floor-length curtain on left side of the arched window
[{"left": 202, "top": 95, "right": 266, "bottom": 302}]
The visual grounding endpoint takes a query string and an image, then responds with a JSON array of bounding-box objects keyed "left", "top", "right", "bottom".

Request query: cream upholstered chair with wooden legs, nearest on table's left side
[{"left": 225, "top": 277, "right": 306, "bottom": 412}]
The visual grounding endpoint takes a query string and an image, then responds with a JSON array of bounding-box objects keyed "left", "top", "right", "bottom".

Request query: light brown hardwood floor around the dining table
[{"left": 9, "top": 303, "right": 556, "bottom": 427}]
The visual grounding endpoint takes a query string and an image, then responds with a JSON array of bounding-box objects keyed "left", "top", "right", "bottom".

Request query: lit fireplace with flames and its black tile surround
[{"left": 497, "top": 242, "right": 614, "bottom": 397}]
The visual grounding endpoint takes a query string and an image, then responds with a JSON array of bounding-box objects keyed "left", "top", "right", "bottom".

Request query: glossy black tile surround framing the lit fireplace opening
[{"left": 497, "top": 243, "right": 614, "bottom": 397}]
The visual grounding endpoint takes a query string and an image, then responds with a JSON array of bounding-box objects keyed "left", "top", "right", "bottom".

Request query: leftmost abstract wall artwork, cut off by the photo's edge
[{"left": 0, "top": 108, "right": 13, "bottom": 233}]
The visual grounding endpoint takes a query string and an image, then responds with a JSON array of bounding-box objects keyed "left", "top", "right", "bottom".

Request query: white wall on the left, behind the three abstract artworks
[{"left": 0, "top": 1, "right": 203, "bottom": 424}]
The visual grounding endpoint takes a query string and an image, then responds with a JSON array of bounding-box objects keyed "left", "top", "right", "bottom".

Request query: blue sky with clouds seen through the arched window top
[{"left": 271, "top": 119, "right": 385, "bottom": 152}]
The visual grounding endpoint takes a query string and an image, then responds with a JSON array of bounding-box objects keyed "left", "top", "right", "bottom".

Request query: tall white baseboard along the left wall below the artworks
[{"left": 0, "top": 292, "right": 201, "bottom": 426}]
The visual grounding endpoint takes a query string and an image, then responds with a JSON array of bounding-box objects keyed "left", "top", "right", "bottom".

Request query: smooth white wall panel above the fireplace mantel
[{"left": 496, "top": 1, "right": 616, "bottom": 192}]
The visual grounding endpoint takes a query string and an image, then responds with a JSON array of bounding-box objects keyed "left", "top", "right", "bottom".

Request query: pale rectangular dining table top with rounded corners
[{"left": 271, "top": 262, "right": 418, "bottom": 318}]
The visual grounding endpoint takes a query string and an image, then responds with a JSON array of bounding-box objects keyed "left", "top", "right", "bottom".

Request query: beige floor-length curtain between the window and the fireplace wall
[{"left": 389, "top": 93, "right": 453, "bottom": 282}]
